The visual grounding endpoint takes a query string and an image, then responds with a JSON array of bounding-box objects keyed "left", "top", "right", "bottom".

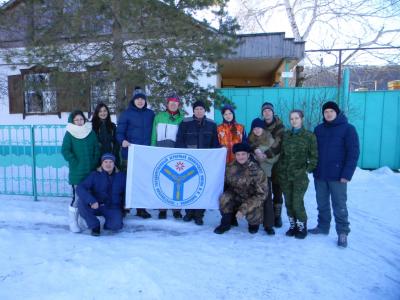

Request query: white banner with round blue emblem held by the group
[{"left": 125, "top": 145, "right": 226, "bottom": 209}]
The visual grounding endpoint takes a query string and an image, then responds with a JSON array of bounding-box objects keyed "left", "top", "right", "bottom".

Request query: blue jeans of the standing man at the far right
[{"left": 314, "top": 179, "right": 350, "bottom": 234}]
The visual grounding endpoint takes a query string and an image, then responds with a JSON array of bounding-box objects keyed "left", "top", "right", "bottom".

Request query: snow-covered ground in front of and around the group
[{"left": 0, "top": 168, "right": 400, "bottom": 300}]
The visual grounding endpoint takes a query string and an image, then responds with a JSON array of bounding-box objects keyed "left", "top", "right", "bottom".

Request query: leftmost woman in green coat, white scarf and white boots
[{"left": 61, "top": 110, "right": 100, "bottom": 232}]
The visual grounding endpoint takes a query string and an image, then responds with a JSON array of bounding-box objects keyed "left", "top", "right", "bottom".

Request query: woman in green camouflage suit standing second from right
[{"left": 278, "top": 110, "right": 318, "bottom": 239}]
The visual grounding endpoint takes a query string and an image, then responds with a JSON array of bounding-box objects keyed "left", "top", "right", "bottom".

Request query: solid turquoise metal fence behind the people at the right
[{"left": 215, "top": 87, "right": 400, "bottom": 169}]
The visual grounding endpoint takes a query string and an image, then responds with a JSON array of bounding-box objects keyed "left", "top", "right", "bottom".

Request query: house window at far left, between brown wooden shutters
[{"left": 24, "top": 73, "right": 57, "bottom": 113}]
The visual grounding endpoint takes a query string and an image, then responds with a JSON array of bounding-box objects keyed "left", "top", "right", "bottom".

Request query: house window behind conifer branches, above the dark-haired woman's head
[{"left": 90, "top": 71, "right": 116, "bottom": 113}]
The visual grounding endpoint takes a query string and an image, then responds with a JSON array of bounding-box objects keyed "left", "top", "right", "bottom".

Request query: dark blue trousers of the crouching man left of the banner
[{"left": 78, "top": 200, "right": 122, "bottom": 230}]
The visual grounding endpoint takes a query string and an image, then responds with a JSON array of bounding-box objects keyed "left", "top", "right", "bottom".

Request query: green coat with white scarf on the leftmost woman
[{"left": 61, "top": 111, "right": 100, "bottom": 185}]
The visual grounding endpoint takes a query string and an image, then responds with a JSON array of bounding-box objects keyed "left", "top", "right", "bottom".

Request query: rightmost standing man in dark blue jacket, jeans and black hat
[{"left": 309, "top": 101, "right": 360, "bottom": 247}]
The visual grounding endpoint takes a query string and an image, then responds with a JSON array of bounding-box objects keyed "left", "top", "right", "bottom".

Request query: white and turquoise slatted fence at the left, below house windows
[{"left": 0, "top": 125, "right": 71, "bottom": 198}]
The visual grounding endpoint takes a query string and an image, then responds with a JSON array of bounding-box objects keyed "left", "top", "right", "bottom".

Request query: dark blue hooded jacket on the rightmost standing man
[{"left": 314, "top": 113, "right": 360, "bottom": 181}]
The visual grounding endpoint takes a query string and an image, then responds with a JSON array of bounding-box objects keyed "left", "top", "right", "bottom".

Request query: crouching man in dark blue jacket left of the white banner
[{"left": 77, "top": 153, "right": 126, "bottom": 236}]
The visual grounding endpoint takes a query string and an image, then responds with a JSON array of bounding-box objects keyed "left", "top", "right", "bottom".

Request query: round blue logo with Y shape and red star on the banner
[{"left": 153, "top": 153, "right": 206, "bottom": 207}]
